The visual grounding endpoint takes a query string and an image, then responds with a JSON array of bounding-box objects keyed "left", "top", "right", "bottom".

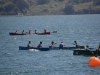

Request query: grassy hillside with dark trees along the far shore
[{"left": 0, "top": 0, "right": 100, "bottom": 15}]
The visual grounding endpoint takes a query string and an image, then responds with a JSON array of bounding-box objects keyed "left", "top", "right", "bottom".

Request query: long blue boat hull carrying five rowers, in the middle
[{"left": 19, "top": 46, "right": 84, "bottom": 51}]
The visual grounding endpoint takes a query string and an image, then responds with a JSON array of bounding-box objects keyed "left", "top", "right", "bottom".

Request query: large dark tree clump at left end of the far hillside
[{"left": 0, "top": 0, "right": 29, "bottom": 15}]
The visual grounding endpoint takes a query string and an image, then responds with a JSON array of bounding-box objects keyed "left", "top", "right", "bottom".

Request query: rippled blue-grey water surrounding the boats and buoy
[{"left": 0, "top": 14, "right": 100, "bottom": 75}]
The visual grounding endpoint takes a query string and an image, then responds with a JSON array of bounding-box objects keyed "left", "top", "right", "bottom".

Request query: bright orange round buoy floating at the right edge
[{"left": 88, "top": 57, "right": 100, "bottom": 67}]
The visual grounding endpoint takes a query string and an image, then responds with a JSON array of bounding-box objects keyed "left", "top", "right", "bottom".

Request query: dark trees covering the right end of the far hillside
[{"left": 64, "top": 0, "right": 100, "bottom": 15}]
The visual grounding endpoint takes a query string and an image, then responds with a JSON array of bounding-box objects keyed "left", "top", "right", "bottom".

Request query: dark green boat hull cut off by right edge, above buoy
[{"left": 73, "top": 50, "right": 100, "bottom": 55}]
